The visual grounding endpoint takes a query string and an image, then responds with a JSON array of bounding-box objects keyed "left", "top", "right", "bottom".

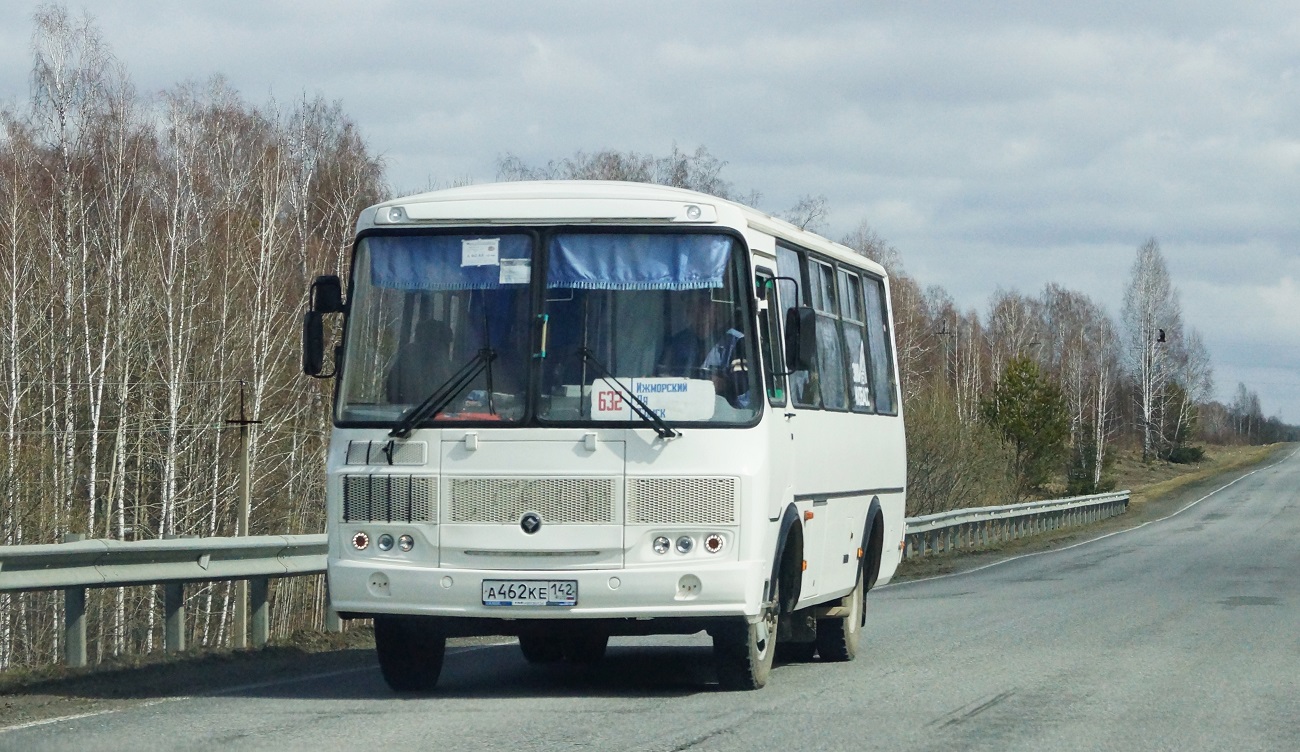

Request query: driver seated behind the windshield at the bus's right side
[{"left": 658, "top": 290, "right": 749, "bottom": 407}]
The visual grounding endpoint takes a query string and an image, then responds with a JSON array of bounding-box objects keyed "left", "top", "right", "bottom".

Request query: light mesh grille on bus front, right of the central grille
[{"left": 628, "top": 477, "right": 736, "bottom": 524}]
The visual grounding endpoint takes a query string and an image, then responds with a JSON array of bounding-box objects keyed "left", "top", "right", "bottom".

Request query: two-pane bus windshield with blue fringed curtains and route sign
[{"left": 337, "top": 229, "right": 761, "bottom": 425}]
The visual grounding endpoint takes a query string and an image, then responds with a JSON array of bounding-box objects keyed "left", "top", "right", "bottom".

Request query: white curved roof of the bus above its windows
[{"left": 356, "top": 180, "right": 887, "bottom": 276}]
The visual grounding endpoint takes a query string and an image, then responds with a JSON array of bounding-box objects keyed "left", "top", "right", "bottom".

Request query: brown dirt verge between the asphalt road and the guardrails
[{"left": 0, "top": 445, "right": 1292, "bottom": 739}]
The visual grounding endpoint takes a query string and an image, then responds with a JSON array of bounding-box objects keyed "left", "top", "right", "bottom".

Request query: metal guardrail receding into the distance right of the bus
[{"left": 904, "top": 490, "right": 1130, "bottom": 558}]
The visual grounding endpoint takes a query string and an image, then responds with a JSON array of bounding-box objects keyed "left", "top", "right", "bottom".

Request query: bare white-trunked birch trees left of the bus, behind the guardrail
[{"left": 0, "top": 7, "right": 384, "bottom": 667}]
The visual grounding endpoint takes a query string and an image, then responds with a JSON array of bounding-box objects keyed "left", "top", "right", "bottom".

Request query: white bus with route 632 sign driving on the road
[{"left": 303, "top": 181, "right": 906, "bottom": 691}]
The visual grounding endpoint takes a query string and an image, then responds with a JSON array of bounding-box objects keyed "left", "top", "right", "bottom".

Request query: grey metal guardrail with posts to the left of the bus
[{"left": 0, "top": 533, "right": 325, "bottom": 666}]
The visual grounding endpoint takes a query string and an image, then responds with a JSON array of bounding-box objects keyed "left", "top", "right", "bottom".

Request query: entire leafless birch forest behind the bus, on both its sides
[{"left": 0, "top": 7, "right": 1295, "bottom": 669}]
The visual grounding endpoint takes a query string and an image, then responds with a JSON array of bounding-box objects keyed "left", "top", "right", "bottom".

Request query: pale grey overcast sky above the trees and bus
[{"left": 0, "top": 0, "right": 1300, "bottom": 423}]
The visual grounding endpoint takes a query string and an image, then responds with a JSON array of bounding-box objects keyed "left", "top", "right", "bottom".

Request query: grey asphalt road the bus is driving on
[{"left": 0, "top": 453, "right": 1300, "bottom": 752}]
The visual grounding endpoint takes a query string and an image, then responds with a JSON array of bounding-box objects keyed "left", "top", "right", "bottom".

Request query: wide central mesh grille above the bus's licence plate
[{"left": 447, "top": 477, "right": 615, "bottom": 524}]
